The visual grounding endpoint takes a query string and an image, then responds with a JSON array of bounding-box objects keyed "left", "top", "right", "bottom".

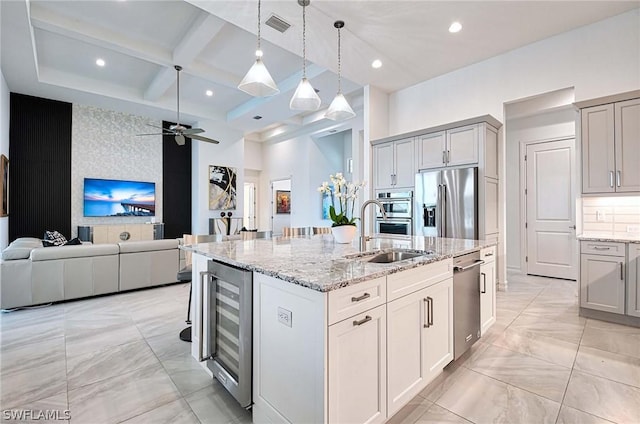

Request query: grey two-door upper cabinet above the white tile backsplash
[{"left": 580, "top": 98, "right": 640, "bottom": 194}]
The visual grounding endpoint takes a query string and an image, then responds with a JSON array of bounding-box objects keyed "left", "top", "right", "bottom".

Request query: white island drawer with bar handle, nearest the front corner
[{"left": 328, "top": 277, "right": 387, "bottom": 325}]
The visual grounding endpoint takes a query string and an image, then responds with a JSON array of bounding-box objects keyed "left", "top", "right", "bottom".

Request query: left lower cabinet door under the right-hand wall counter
[{"left": 580, "top": 253, "right": 625, "bottom": 314}]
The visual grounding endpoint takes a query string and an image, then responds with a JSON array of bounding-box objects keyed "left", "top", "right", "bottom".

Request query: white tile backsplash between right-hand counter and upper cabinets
[{"left": 582, "top": 196, "right": 640, "bottom": 236}]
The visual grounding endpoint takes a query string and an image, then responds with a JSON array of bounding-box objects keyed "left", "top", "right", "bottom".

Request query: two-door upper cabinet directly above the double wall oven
[{"left": 373, "top": 137, "right": 415, "bottom": 190}]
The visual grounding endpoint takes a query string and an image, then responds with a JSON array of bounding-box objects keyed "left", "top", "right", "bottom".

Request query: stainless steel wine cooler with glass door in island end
[{"left": 198, "top": 261, "right": 253, "bottom": 408}]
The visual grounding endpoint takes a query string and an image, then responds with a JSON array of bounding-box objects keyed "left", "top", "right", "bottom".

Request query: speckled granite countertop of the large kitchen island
[{"left": 181, "top": 234, "right": 496, "bottom": 292}]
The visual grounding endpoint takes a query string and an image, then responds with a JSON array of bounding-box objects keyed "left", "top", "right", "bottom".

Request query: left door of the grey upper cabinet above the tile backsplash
[{"left": 581, "top": 104, "right": 615, "bottom": 193}]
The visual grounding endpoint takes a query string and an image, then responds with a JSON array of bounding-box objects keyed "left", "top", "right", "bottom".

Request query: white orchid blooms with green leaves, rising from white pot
[{"left": 318, "top": 172, "right": 365, "bottom": 227}]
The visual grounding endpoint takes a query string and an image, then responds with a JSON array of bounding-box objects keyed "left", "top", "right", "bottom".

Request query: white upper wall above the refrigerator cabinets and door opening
[{"left": 388, "top": 9, "right": 640, "bottom": 136}]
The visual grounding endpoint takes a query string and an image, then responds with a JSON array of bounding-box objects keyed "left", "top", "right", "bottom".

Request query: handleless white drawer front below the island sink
[{"left": 387, "top": 259, "right": 453, "bottom": 302}]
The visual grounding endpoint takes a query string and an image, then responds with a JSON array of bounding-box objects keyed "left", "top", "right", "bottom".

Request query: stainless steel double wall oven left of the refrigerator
[{"left": 375, "top": 191, "right": 413, "bottom": 235}]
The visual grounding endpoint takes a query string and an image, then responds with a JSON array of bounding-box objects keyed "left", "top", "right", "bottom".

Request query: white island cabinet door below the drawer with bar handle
[{"left": 328, "top": 305, "right": 387, "bottom": 423}]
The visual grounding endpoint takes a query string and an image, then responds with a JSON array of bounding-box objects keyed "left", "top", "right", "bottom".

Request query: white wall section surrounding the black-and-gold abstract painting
[{"left": 191, "top": 121, "right": 245, "bottom": 234}]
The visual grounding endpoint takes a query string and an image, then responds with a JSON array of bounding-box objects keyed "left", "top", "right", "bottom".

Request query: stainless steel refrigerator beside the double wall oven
[{"left": 413, "top": 167, "right": 478, "bottom": 239}]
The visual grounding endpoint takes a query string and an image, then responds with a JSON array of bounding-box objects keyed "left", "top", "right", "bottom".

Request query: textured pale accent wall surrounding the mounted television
[{"left": 71, "top": 104, "right": 162, "bottom": 237}]
